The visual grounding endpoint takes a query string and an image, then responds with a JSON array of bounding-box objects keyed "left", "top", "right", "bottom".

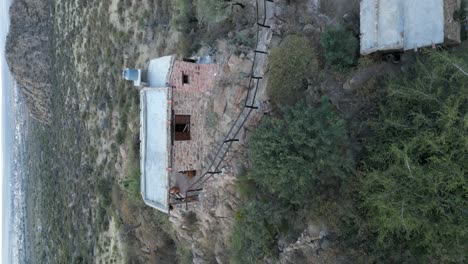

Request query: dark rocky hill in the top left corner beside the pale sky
[{"left": 5, "top": 0, "right": 52, "bottom": 123}]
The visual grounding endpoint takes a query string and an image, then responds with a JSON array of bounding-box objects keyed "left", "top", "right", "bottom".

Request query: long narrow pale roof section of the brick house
[{"left": 140, "top": 87, "right": 172, "bottom": 213}]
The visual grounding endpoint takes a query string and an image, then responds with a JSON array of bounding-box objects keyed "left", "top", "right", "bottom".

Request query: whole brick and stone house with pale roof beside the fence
[{"left": 133, "top": 56, "right": 218, "bottom": 213}]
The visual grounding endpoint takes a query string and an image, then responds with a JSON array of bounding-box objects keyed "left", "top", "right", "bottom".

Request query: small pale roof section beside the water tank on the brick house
[{"left": 147, "top": 56, "right": 174, "bottom": 87}]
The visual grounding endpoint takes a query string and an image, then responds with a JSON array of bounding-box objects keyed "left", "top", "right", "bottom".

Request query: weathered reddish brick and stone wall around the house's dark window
[{"left": 169, "top": 61, "right": 218, "bottom": 175}]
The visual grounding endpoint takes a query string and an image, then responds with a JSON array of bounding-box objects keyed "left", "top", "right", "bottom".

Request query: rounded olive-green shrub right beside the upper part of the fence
[{"left": 267, "top": 36, "right": 318, "bottom": 106}]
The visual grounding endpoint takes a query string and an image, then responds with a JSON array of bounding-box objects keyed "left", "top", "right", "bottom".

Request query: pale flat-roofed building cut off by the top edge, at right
[{"left": 360, "top": 0, "right": 461, "bottom": 55}]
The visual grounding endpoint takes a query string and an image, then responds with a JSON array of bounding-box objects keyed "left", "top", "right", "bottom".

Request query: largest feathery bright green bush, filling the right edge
[{"left": 359, "top": 52, "right": 468, "bottom": 263}]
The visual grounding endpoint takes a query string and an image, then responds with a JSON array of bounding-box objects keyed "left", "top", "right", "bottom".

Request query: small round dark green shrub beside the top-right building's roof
[{"left": 320, "top": 27, "right": 359, "bottom": 67}]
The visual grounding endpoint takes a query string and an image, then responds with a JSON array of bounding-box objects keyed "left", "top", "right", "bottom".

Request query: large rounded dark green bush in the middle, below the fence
[{"left": 248, "top": 98, "right": 353, "bottom": 204}]
